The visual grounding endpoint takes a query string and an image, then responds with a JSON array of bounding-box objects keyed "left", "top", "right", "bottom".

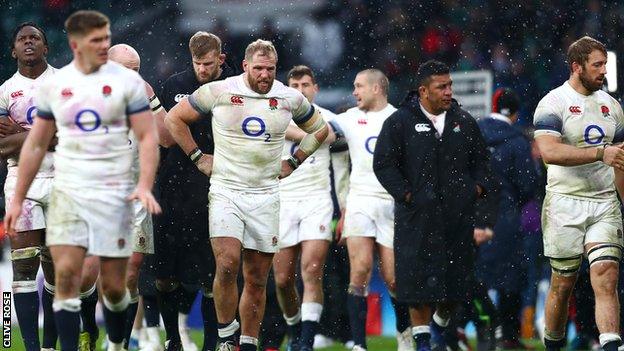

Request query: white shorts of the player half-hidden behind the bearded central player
[{"left": 279, "top": 193, "right": 334, "bottom": 248}]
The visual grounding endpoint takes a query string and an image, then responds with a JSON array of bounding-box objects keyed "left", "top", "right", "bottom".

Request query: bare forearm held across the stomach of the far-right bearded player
[{"left": 535, "top": 135, "right": 624, "bottom": 170}]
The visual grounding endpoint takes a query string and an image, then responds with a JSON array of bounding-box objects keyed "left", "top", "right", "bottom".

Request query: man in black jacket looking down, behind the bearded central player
[{"left": 154, "top": 32, "right": 236, "bottom": 351}]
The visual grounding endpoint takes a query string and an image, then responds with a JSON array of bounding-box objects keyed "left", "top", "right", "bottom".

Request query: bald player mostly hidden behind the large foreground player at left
[{"left": 108, "top": 44, "right": 173, "bottom": 350}]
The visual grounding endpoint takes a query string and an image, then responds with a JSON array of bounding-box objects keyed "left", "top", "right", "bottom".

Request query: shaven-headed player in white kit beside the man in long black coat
[{"left": 335, "top": 69, "right": 412, "bottom": 351}]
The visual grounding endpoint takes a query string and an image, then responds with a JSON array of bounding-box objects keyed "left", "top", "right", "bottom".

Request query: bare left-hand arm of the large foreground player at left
[{"left": 4, "top": 118, "right": 56, "bottom": 235}]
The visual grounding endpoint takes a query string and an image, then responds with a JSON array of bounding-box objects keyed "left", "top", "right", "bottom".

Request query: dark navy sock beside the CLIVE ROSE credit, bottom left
[{"left": 13, "top": 291, "right": 41, "bottom": 351}]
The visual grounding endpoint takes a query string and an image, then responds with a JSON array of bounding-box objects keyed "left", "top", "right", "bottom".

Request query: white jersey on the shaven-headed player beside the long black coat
[{"left": 336, "top": 104, "right": 396, "bottom": 199}]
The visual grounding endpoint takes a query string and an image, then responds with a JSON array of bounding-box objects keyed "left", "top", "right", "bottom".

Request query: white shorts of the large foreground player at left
[{"left": 46, "top": 186, "right": 134, "bottom": 257}]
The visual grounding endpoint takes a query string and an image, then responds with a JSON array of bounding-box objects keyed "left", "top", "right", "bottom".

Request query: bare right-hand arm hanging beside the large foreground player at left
[{"left": 128, "top": 110, "right": 161, "bottom": 213}]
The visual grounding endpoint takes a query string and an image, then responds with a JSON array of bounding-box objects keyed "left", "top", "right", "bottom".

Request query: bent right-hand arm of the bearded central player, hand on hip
[{"left": 280, "top": 110, "right": 329, "bottom": 178}]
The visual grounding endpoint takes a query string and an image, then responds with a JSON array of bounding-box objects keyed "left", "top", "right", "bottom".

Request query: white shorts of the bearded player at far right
[{"left": 542, "top": 192, "right": 623, "bottom": 258}]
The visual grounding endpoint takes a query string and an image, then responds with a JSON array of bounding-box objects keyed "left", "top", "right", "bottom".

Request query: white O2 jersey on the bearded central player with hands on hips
[{"left": 189, "top": 74, "right": 314, "bottom": 191}]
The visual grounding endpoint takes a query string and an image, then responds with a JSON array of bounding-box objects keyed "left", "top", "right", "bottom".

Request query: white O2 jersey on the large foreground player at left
[{"left": 35, "top": 61, "right": 149, "bottom": 188}]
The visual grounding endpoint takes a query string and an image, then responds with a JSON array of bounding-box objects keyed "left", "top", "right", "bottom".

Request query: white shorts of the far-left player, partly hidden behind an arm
[{"left": 4, "top": 176, "right": 54, "bottom": 232}]
